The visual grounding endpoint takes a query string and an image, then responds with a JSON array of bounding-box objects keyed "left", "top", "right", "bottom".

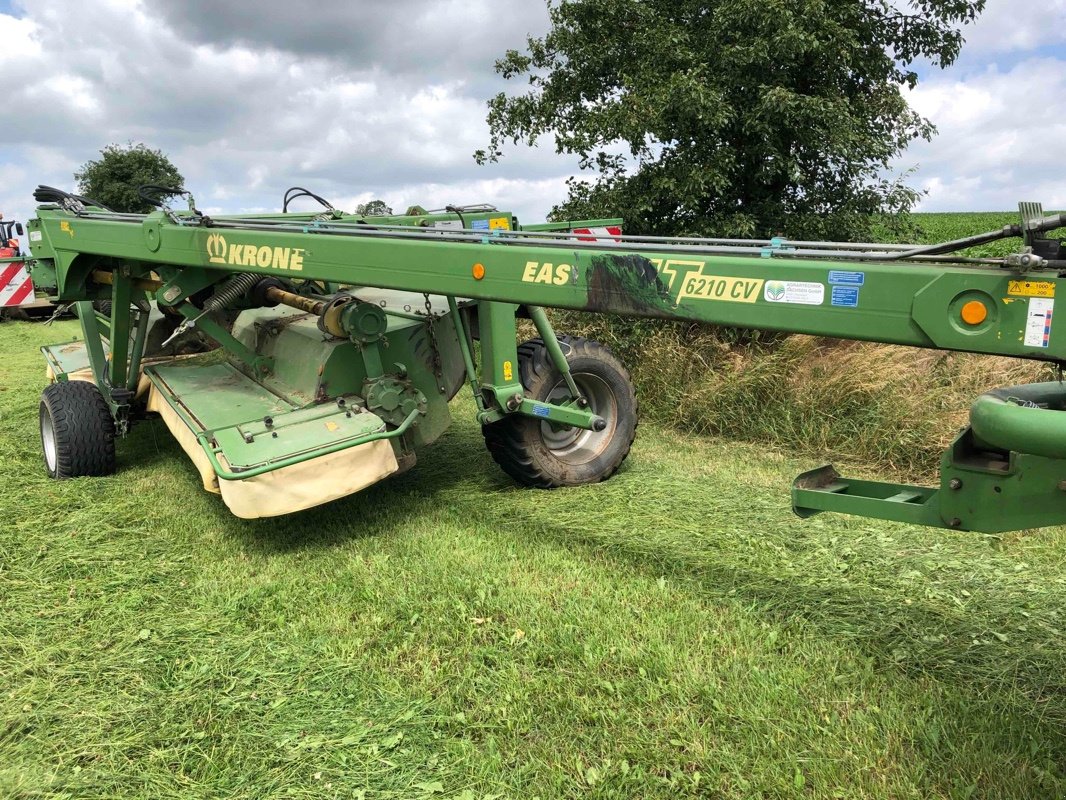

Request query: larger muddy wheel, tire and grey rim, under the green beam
[{"left": 482, "top": 336, "right": 637, "bottom": 489}]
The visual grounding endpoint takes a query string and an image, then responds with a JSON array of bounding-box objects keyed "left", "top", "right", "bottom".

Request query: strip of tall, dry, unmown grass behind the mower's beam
[{"left": 555, "top": 212, "right": 1053, "bottom": 480}]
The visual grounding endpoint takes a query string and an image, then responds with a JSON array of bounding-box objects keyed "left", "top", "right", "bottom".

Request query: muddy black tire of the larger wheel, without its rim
[{"left": 482, "top": 336, "right": 637, "bottom": 489}]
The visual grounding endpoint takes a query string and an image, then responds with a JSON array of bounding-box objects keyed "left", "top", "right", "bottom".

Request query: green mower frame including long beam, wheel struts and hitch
[{"left": 30, "top": 206, "right": 1066, "bottom": 530}]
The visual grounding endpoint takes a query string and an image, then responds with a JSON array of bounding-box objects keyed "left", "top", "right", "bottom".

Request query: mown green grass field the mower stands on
[{"left": 6, "top": 216, "right": 1066, "bottom": 800}]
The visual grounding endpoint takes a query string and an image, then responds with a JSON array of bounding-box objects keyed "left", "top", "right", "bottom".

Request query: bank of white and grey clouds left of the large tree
[{"left": 0, "top": 0, "right": 576, "bottom": 231}]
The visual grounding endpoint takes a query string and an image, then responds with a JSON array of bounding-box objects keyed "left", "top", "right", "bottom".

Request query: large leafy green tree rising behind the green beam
[{"left": 474, "top": 0, "right": 985, "bottom": 238}]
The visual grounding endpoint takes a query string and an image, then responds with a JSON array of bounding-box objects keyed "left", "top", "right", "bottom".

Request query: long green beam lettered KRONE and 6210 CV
[{"left": 25, "top": 207, "right": 1066, "bottom": 360}]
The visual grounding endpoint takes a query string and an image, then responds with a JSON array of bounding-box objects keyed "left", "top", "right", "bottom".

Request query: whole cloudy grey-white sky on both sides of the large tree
[{"left": 0, "top": 0, "right": 1066, "bottom": 228}]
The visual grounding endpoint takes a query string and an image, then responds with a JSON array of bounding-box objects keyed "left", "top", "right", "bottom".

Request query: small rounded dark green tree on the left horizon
[{"left": 74, "top": 142, "right": 184, "bottom": 213}]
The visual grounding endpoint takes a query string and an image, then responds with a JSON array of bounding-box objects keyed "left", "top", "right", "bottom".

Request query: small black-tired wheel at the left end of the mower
[{"left": 41, "top": 381, "right": 115, "bottom": 478}]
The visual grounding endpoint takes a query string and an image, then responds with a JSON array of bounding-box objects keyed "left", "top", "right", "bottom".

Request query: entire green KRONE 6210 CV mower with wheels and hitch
[{"left": 20, "top": 187, "right": 1066, "bottom": 531}]
